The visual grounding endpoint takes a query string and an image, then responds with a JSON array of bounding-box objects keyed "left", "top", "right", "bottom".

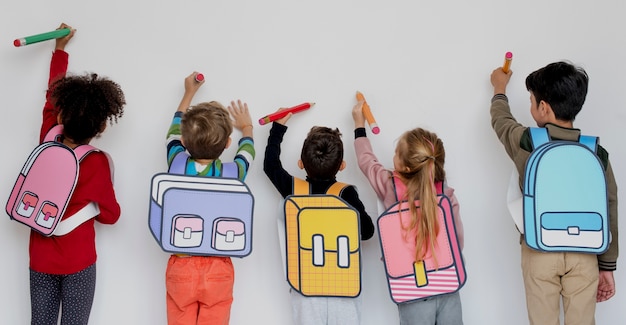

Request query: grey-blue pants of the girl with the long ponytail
[{"left": 398, "top": 292, "right": 463, "bottom": 325}]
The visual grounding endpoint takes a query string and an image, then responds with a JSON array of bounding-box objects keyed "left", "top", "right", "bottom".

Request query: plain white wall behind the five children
[{"left": 0, "top": 0, "right": 626, "bottom": 325}]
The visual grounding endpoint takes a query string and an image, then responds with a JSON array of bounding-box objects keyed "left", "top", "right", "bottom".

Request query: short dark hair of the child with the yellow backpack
[{"left": 300, "top": 126, "right": 343, "bottom": 180}]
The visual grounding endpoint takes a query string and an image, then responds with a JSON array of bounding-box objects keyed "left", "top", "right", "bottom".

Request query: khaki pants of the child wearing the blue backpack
[{"left": 522, "top": 243, "right": 598, "bottom": 325}]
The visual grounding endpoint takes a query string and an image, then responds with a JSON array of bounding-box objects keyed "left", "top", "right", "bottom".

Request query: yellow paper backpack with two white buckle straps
[{"left": 284, "top": 177, "right": 361, "bottom": 297}]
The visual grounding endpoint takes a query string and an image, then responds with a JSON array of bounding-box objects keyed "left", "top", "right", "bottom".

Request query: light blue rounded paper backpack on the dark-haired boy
[{"left": 523, "top": 128, "right": 610, "bottom": 254}]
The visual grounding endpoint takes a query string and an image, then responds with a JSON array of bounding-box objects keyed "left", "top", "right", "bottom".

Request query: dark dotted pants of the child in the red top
[{"left": 30, "top": 263, "right": 96, "bottom": 325}]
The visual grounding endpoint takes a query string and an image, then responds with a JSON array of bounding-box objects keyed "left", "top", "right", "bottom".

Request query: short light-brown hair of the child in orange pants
[{"left": 180, "top": 101, "right": 233, "bottom": 159}]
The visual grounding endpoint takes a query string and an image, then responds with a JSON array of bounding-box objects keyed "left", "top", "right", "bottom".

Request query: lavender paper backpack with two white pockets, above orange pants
[{"left": 148, "top": 152, "right": 254, "bottom": 257}]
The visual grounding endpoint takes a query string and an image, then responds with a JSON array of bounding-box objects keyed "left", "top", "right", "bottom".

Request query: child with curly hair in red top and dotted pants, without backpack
[{"left": 29, "top": 24, "right": 126, "bottom": 325}]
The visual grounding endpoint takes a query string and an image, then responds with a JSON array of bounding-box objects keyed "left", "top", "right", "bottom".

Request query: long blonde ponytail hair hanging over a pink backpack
[{"left": 396, "top": 128, "right": 446, "bottom": 263}]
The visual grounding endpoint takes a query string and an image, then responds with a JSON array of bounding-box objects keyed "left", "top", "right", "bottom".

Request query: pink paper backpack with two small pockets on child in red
[{"left": 6, "top": 125, "right": 99, "bottom": 236}]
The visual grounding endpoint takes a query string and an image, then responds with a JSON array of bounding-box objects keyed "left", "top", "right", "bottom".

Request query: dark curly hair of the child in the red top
[{"left": 49, "top": 73, "right": 126, "bottom": 144}]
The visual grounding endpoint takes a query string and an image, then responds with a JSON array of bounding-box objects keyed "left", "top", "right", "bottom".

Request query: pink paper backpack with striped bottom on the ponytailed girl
[{"left": 378, "top": 177, "right": 466, "bottom": 304}]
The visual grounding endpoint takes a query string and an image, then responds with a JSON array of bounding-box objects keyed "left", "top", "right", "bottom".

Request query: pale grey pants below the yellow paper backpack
[{"left": 289, "top": 289, "right": 361, "bottom": 325}]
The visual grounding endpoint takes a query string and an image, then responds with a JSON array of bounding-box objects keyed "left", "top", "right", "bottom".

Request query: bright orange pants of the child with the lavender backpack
[{"left": 165, "top": 255, "right": 235, "bottom": 325}]
